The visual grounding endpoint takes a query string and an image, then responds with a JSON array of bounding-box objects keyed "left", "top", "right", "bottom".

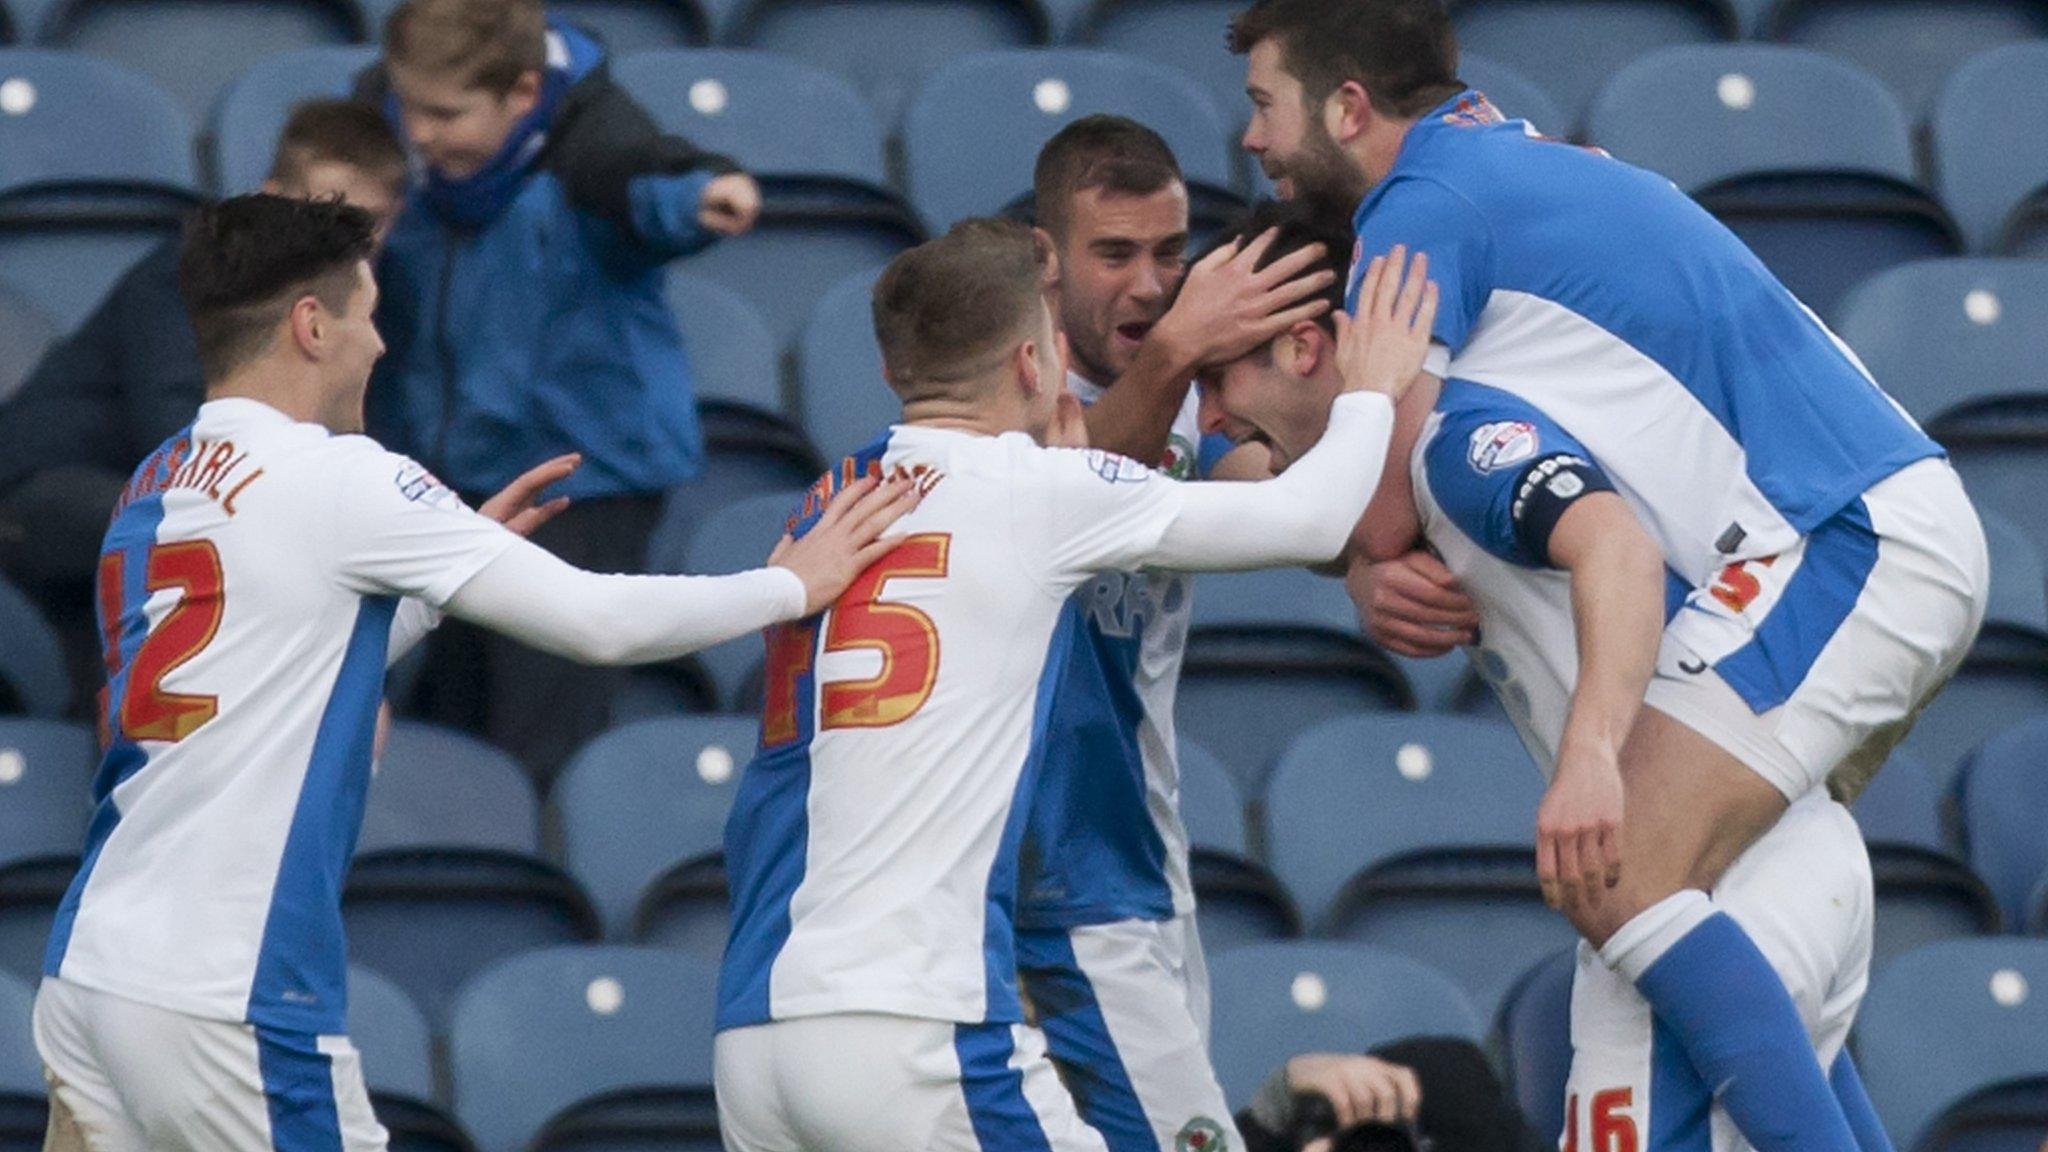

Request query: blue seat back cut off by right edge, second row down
[{"left": 1931, "top": 41, "right": 2048, "bottom": 252}]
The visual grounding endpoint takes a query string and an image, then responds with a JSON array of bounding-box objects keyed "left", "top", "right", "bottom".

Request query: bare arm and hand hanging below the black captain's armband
[{"left": 1536, "top": 492, "right": 1665, "bottom": 908}]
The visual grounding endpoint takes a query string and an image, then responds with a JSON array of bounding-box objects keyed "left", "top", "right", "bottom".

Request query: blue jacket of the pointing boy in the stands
[{"left": 358, "top": 20, "right": 735, "bottom": 498}]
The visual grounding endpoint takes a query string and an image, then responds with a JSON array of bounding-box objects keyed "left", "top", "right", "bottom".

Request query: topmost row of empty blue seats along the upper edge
[{"left": 0, "top": 0, "right": 2048, "bottom": 131}]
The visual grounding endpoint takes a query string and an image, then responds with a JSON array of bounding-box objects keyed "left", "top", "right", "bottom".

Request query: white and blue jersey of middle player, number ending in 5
[{"left": 719, "top": 426, "right": 1178, "bottom": 1027}]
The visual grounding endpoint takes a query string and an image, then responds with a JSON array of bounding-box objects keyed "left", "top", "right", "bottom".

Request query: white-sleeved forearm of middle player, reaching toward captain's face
[{"left": 1149, "top": 392, "right": 1395, "bottom": 572}]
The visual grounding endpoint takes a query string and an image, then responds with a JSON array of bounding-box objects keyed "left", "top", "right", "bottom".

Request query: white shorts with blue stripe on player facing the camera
[{"left": 1018, "top": 920, "right": 1241, "bottom": 1152}]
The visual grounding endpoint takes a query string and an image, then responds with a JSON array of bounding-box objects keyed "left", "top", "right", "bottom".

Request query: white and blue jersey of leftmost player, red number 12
[{"left": 45, "top": 400, "right": 510, "bottom": 1031}]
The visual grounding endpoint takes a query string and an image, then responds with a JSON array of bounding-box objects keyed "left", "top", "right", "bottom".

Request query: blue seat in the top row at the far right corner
[{"left": 1763, "top": 0, "right": 2048, "bottom": 123}]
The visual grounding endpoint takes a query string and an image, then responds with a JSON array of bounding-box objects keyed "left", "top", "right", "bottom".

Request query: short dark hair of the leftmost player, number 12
[{"left": 178, "top": 195, "right": 377, "bottom": 385}]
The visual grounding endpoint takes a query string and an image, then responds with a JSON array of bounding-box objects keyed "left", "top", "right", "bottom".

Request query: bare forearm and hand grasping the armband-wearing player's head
[{"left": 1087, "top": 230, "right": 1337, "bottom": 461}]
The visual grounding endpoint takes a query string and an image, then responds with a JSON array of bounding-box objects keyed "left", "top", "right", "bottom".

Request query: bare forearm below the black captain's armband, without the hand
[{"left": 1561, "top": 512, "right": 1665, "bottom": 756}]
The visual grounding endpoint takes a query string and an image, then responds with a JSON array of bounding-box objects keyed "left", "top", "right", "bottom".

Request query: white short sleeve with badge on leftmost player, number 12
[{"left": 315, "top": 437, "right": 518, "bottom": 609}]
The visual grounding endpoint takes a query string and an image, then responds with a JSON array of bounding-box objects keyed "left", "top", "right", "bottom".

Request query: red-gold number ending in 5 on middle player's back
[{"left": 762, "top": 533, "right": 952, "bottom": 748}]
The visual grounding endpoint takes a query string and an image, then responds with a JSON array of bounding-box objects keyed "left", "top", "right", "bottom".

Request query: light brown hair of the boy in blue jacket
[{"left": 383, "top": 0, "right": 547, "bottom": 96}]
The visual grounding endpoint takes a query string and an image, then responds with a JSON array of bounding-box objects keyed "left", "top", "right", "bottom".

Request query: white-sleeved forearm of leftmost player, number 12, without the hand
[{"left": 449, "top": 541, "right": 805, "bottom": 664}]
